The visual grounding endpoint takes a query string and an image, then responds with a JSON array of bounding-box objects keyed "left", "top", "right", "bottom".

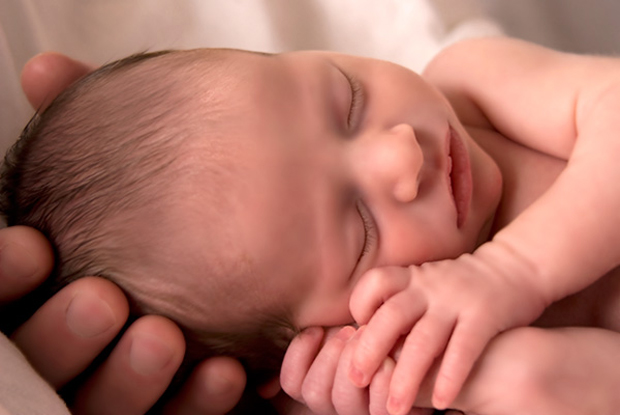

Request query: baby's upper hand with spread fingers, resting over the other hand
[{"left": 349, "top": 254, "right": 545, "bottom": 415}]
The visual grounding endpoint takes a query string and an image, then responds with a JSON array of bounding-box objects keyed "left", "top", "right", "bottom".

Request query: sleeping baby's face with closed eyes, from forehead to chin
[{"left": 172, "top": 52, "right": 501, "bottom": 328}]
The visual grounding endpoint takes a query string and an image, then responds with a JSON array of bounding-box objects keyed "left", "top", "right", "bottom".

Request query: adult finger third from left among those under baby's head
[{"left": 71, "top": 315, "right": 185, "bottom": 415}]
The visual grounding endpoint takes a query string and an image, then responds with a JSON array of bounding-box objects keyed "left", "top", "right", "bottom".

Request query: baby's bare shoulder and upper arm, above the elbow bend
[{"left": 423, "top": 38, "right": 620, "bottom": 159}]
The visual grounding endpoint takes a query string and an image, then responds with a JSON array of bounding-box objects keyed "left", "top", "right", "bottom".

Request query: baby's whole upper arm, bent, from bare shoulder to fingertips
[{"left": 351, "top": 38, "right": 620, "bottom": 413}]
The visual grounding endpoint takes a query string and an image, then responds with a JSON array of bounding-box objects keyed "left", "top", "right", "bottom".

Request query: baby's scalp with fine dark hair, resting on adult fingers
[{"left": 2, "top": 51, "right": 300, "bottom": 386}]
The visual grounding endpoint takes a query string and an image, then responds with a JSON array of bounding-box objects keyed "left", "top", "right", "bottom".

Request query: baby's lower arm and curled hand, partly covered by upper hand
[{"left": 281, "top": 327, "right": 620, "bottom": 415}]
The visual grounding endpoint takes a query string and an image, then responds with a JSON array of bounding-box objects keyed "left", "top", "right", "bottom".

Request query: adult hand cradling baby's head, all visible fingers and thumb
[{"left": 0, "top": 53, "right": 246, "bottom": 415}]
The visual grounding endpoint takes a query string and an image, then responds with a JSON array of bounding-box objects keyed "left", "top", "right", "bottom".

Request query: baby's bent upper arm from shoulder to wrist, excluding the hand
[{"left": 425, "top": 38, "right": 620, "bottom": 304}]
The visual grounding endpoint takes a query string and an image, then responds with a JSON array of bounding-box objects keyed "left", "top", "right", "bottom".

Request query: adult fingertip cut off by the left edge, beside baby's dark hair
[{"left": 0, "top": 226, "right": 54, "bottom": 303}]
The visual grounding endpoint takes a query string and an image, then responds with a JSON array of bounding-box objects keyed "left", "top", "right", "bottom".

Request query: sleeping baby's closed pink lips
[{"left": 447, "top": 127, "right": 472, "bottom": 228}]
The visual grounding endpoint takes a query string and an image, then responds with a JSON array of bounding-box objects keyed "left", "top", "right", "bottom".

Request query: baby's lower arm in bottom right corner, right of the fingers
[{"left": 454, "top": 327, "right": 620, "bottom": 415}]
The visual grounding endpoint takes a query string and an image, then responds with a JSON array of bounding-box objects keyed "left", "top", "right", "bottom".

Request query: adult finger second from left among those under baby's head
[{"left": 11, "top": 277, "right": 129, "bottom": 388}]
